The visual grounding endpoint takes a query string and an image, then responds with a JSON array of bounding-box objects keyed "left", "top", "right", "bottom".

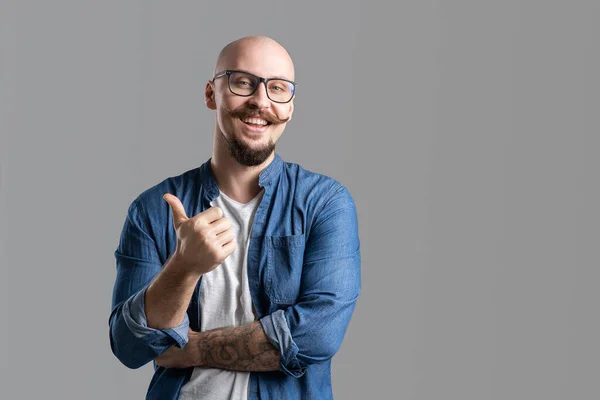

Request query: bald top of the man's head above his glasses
[{"left": 213, "top": 36, "right": 295, "bottom": 81}]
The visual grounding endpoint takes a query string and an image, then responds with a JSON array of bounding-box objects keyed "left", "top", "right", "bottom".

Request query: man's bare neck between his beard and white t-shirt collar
[{"left": 210, "top": 132, "right": 275, "bottom": 203}]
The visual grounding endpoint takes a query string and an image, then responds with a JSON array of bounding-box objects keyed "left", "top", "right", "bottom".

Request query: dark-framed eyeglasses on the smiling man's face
[{"left": 212, "top": 69, "right": 298, "bottom": 103}]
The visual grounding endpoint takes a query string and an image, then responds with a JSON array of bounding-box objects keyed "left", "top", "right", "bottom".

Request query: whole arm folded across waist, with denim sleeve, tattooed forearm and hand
[{"left": 156, "top": 187, "right": 360, "bottom": 377}]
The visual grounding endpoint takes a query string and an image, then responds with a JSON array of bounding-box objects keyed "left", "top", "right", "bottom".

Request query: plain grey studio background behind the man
[{"left": 0, "top": 0, "right": 600, "bottom": 400}]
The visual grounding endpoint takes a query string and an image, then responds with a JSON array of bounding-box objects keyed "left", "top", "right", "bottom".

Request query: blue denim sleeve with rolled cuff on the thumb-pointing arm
[{"left": 109, "top": 199, "right": 189, "bottom": 368}]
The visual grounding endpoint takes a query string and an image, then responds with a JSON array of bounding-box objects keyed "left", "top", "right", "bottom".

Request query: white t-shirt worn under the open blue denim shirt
[{"left": 179, "top": 189, "right": 264, "bottom": 400}]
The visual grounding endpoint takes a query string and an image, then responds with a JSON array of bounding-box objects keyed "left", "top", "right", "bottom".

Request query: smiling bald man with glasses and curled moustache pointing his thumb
[{"left": 109, "top": 36, "right": 361, "bottom": 400}]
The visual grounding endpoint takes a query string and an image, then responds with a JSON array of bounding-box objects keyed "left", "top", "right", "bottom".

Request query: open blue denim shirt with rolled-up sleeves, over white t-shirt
[{"left": 109, "top": 153, "right": 361, "bottom": 400}]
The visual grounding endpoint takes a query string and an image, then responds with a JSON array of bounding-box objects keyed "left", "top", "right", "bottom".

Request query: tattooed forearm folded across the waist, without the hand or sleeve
[{"left": 195, "top": 321, "right": 280, "bottom": 371}]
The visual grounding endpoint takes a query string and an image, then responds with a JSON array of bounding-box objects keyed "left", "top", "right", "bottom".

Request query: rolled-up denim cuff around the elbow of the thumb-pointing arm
[{"left": 123, "top": 287, "right": 190, "bottom": 348}]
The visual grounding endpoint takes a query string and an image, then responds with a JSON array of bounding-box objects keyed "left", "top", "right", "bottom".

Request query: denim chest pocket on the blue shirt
[{"left": 265, "top": 234, "right": 305, "bottom": 304}]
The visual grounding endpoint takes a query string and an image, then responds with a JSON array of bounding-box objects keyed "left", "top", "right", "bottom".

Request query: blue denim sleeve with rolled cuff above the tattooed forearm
[{"left": 260, "top": 185, "right": 361, "bottom": 377}]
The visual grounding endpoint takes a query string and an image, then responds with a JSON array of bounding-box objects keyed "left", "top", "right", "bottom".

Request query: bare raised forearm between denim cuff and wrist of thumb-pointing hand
[{"left": 144, "top": 256, "right": 200, "bottom": 329}]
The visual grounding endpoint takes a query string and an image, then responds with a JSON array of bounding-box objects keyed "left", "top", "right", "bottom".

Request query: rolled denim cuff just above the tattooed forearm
[{"left": 260, "top": 310, "right": 306, "bottom": 378}]
